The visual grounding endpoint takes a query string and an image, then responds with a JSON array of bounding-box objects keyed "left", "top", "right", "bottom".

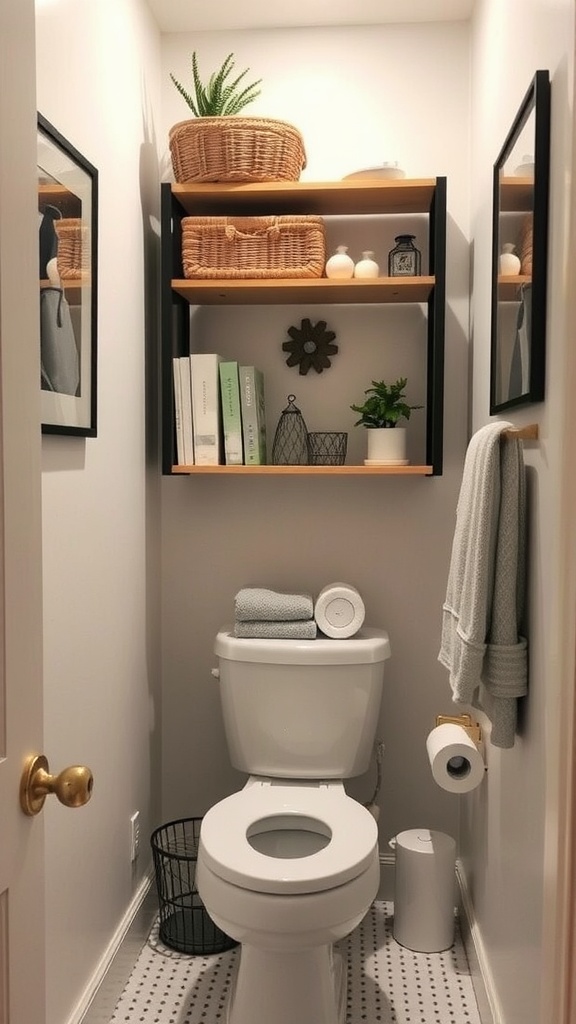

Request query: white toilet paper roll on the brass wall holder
[{"left": 426, "top": 722, "right": 485, "bottom": 793}]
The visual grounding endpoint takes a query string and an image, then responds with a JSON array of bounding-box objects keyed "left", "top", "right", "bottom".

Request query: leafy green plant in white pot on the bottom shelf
[{"left": 344, "top": 377, "right": 422, "bottom": 466}]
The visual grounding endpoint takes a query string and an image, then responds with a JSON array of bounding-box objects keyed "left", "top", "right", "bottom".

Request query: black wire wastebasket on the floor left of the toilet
[{"left": 150, "top": 818, "right": 238, "bottom": 955}]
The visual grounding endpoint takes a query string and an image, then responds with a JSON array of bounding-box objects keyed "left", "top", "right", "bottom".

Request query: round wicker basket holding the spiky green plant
[{"left": 169, "top": 117, "right": 306, "bottom": 183}]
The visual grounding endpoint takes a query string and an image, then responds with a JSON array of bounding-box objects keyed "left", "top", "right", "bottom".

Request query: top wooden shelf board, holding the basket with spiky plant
[{"left": 172, "top": 178, "right": 436, "bottom": 216}]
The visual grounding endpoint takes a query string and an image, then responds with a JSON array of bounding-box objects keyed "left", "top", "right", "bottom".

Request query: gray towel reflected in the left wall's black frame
[{"left": 40, "top": 288, "right": 80, "bottom": 395}]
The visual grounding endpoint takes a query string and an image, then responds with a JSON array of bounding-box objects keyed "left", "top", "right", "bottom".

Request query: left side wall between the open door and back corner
[{"left": 37, "top": 0, "right": 160, "bottom": 1024}]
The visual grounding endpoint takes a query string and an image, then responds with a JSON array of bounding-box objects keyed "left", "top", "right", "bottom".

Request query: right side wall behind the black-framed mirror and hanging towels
[{"left": 462, "top": 0, "right": 574, "bottom": 1024}]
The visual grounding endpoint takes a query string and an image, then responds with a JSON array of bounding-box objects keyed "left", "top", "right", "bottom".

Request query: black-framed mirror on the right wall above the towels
[{"left": 490, "top": 71, "right": 550, "bottom": 414}]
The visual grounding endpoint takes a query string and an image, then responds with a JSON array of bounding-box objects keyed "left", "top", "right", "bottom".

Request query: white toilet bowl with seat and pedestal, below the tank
[{"left": 196, "top": 778, "right": 379, "bottom": 1024}]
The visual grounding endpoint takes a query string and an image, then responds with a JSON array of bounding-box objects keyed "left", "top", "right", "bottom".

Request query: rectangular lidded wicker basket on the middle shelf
[{"left": 181, "top": 215, "right": 326, "bottom": 280}]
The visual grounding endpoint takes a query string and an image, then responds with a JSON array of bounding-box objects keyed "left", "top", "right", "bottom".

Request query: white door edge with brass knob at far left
[{"left": 0, "top": 0, "right": 45, "bottom": 1024}]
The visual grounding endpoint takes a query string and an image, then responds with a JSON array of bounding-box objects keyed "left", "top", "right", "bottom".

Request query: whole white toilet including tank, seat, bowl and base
[{"left": 196, "top": 627, "right": 389, "bottom": 1024}]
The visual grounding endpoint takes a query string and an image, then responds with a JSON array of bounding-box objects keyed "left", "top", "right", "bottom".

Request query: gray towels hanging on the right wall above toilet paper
[{"left": 439, "top": 421, "right": 528, "bottom": 748}]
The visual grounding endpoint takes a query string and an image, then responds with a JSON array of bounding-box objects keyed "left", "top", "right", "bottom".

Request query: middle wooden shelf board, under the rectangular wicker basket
[{"left": 172, "top": 278, "right": 435, "bottom": 305}]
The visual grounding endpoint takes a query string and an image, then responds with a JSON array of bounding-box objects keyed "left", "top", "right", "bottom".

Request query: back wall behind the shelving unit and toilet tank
[{"left": 157, "top": 24, "right": 469, "bottom": 850}]
